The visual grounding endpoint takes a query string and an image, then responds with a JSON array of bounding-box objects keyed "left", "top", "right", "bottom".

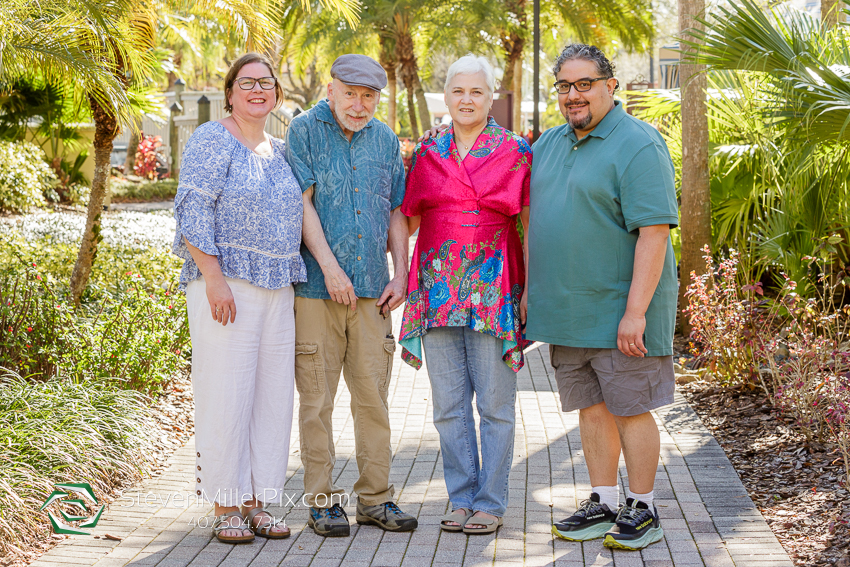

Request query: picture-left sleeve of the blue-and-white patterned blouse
[{"left": 171, "top": 122, "right": 234, "bottom": 260}]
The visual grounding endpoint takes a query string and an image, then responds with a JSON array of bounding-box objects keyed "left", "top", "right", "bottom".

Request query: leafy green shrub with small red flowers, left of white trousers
[{"left": 0, "top": 254, "right": 189, "bottom": 393}]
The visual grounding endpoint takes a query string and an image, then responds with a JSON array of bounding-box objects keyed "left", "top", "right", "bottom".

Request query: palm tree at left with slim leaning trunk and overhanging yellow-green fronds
[{"left": 0, "top": 0, "right": 357, "bottom": 304}]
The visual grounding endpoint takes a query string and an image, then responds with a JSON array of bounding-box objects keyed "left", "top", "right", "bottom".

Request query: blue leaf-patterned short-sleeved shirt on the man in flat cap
[{"left": 286, "top": 99, "right": 404, "bottom": 299}]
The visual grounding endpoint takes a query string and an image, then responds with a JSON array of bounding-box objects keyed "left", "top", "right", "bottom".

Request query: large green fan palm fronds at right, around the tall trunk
[{"left": 635, "top": 1, "right": 850, "bottom": 294}]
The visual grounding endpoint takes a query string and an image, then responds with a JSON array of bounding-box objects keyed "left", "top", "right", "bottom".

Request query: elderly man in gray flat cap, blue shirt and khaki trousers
[{"left": 286, "top": 55, "right": 418, "bottom": 536}]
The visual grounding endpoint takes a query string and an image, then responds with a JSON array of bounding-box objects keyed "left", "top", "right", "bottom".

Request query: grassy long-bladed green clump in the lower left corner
[{"left": 0, "top": 372, "right": 159, "bottom": 555}]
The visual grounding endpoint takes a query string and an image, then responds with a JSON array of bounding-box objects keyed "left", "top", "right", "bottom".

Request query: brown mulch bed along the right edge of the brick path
[{"left": 677, "top": 381, "right": 850, "bottom": 567}]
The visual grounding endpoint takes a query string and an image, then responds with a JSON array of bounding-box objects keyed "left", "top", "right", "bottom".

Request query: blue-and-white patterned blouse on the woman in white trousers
[{"left": 171, "top": 122, "right": 307, "bottom": 289}]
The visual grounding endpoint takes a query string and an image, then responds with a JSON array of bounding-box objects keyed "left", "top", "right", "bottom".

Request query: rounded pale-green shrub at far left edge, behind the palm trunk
[{"left": 0, "top": 141, "right": 58, "bottom": 213}]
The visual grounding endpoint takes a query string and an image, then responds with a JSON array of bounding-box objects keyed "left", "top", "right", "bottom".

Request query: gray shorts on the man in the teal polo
[{"left": 549, "top": 345, "right": 676, "bottom": 417}]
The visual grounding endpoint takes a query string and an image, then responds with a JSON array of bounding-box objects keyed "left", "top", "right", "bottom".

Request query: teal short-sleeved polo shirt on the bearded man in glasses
[{"left": 525, "top": 102, "right": 679, "bottom": 356}]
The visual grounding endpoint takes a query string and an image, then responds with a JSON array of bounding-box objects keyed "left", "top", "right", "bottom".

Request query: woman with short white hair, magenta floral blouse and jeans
[{"left": 400, "top": 55, "right": 531, "bottom": 534}]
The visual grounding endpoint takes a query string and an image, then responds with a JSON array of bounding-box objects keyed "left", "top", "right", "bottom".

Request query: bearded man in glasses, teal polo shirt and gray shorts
[{"left": 526, "top": 44, "right": 679, "bottom": 549}]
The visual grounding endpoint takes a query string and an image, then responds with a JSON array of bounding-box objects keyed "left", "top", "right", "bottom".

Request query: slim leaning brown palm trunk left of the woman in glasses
[{"left": 71, "top": 97, "right": 118, "bottom": 306}]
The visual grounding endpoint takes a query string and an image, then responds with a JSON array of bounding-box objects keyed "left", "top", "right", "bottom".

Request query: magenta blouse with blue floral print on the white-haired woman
[{"left": 399, "top": 118, "right": 531, "bottom": 371}]
